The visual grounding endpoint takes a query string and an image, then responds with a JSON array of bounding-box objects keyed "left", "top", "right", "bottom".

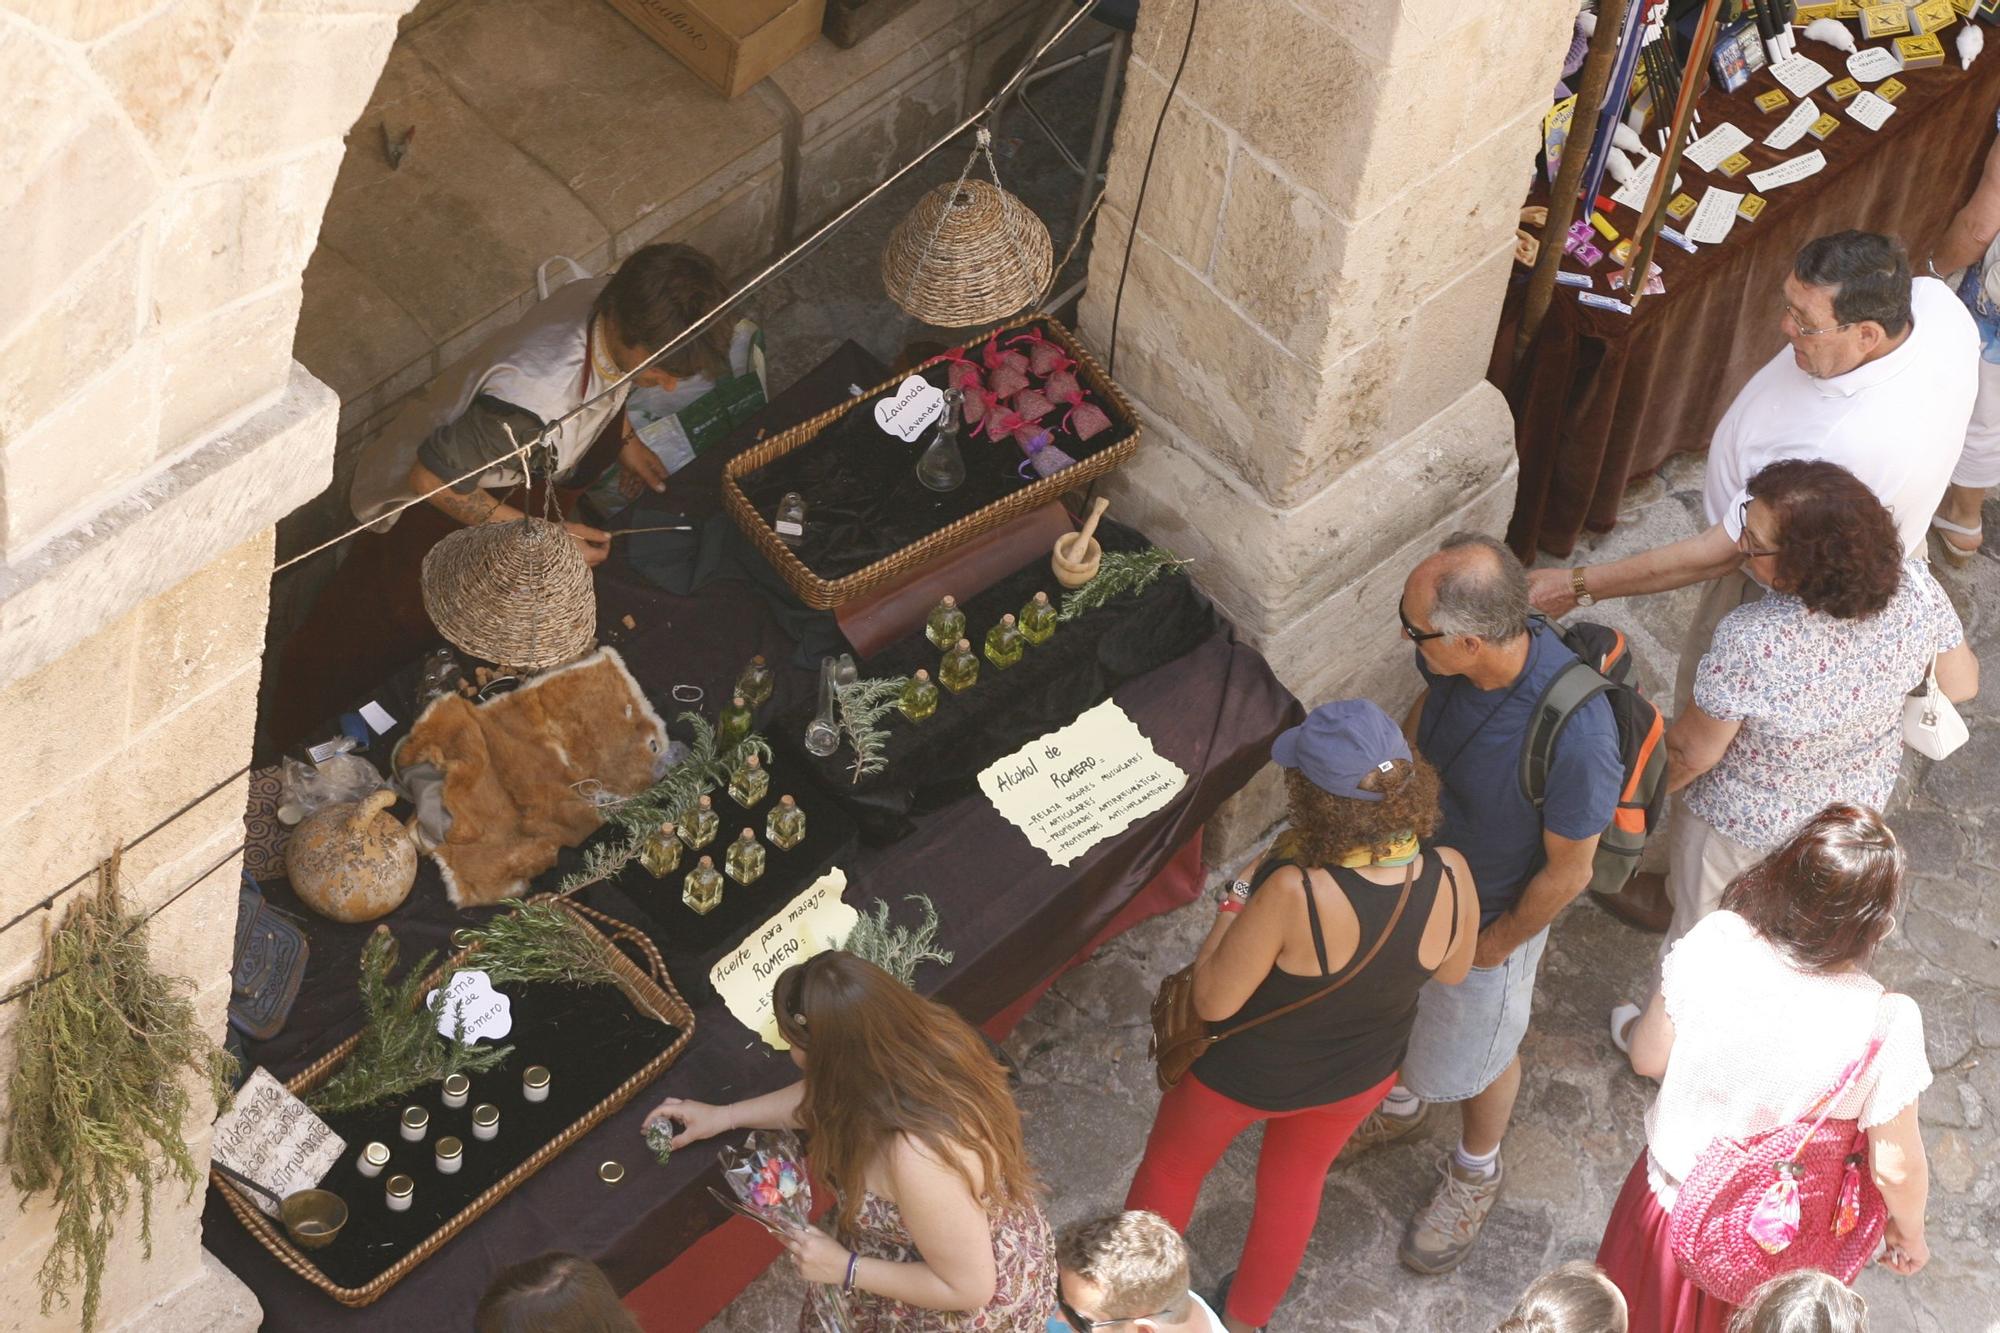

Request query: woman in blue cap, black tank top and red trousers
[{"left": 1126, "top": 699, "right": 1480, "bottom": 1333}]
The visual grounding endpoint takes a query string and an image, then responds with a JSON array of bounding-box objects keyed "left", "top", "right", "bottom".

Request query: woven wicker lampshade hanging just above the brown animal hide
[{"left": 422, "top": 518, "right": 598, "bottom": 671}]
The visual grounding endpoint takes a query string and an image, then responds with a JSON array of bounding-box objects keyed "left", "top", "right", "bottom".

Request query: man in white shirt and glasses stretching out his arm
[{"left": 1530, "top": 232, "right": 1980, "bottom": 931}]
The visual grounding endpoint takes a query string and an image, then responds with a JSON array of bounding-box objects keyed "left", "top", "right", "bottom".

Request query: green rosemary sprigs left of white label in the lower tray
[{"left": 306, "top": 927, "right": 514, "bottom": 1115}]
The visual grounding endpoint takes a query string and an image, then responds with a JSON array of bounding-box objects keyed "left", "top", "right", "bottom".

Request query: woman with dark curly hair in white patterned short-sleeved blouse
[{"left": 1612, "top": 458, "right": 1980, "bottom": 1051}]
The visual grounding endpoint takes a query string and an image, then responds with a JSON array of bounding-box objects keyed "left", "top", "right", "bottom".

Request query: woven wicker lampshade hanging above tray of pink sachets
[{"left": 882, "top": 178, "right": 1056, "bottom": 328}]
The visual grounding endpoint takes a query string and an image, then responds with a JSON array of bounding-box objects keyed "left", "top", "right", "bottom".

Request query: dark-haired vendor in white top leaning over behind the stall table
[{"left": 264, "top": 244, "right": 764, "bottom": 745}]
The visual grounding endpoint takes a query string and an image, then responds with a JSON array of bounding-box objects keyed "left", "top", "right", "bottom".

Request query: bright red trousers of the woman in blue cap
[{"left": 1126, "top": 1073, "right": 1396, "bottom": 1327}]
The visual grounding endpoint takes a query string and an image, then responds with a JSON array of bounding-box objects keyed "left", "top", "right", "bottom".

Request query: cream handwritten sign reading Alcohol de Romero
[{"left": 980, "top": 699, "right": 1188, "bottom": 865}]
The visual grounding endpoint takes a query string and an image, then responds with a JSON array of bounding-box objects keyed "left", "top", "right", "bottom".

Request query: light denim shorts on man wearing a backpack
[{"left": 1396, "top": 927, "right": 1548, "bottom": 1101}]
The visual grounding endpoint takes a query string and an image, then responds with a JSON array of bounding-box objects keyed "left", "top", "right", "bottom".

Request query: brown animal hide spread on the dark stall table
[{"left": 396, "top": 648, "right": 666, "bottom": 907}]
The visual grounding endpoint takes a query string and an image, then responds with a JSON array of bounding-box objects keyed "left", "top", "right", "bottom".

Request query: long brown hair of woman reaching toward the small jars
[{"left": 772, "top": 951, "right": 1036, "bottom": 1227}]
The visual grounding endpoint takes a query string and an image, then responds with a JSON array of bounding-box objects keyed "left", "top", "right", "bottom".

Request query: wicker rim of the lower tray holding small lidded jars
[{"left": 210, "top": 899, "right": 694, "bottom": 1307}]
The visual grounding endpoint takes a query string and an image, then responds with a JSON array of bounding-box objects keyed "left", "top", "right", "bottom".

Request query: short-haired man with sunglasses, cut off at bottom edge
[{"left": 1048, "top": 1211, "right": 1224, "bottom": 1333}]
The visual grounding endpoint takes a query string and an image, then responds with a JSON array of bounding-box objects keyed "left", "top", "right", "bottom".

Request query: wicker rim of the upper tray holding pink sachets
[{"left": 722, "top": 314, "right": 1138, "bottom": 610}]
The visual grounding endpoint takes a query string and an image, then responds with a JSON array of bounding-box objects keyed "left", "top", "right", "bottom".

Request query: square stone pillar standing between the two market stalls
[{"left": 1080, "top": 0, "right": 1576, "bottom": 855}]
